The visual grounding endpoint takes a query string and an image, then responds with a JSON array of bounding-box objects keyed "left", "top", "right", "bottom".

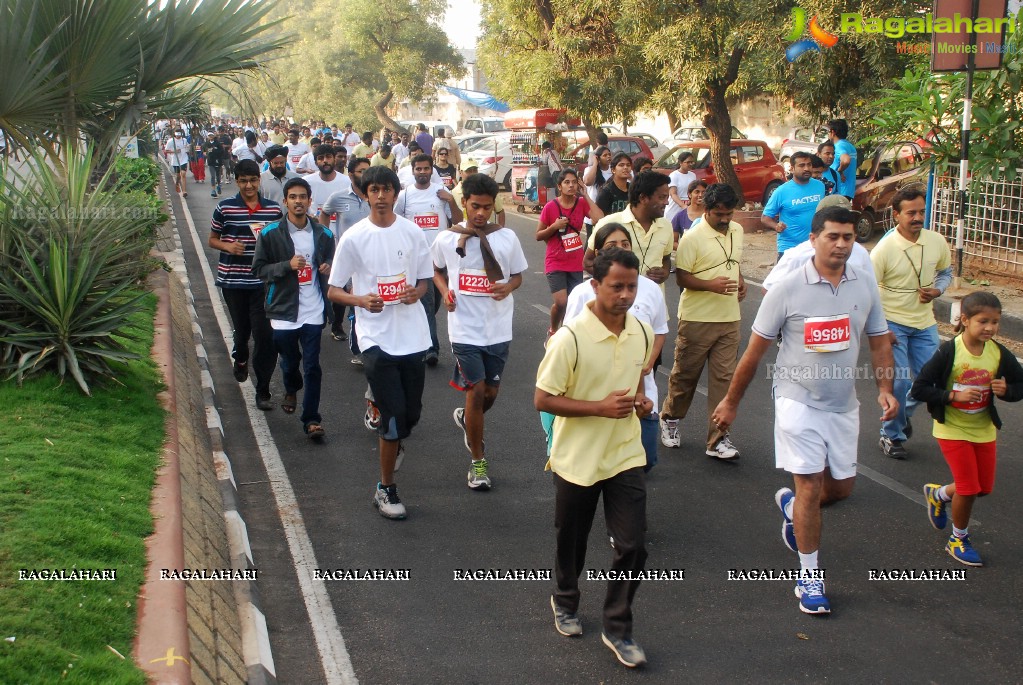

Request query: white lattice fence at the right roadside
[{"left": 931, "top": 165, "right": 1023, "bottom": 276}]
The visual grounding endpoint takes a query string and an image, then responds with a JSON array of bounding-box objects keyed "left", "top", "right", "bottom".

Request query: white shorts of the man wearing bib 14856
[{"left": 774, "top": 397, "right": 859, "bottom": 481}]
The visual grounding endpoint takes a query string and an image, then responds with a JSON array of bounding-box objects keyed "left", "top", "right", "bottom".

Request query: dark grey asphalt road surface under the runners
[{"left": 174, "top": 176, "right": 1023, "bottom": 683}]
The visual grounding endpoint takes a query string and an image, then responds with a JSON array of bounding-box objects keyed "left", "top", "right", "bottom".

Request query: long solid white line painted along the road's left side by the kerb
[{"left": 169, "top": 179, "right": 359, "bottom": 685}]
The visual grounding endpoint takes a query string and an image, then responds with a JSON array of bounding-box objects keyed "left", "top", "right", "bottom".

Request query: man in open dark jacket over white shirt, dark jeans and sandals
[{"left": 251, "top": 178, "right": 333, "bottom": 441}]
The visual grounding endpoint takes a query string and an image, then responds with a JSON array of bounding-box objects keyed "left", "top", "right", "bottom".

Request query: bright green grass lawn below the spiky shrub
[{"left": 0, "top": 295, "right": 164, "bottom": 684}]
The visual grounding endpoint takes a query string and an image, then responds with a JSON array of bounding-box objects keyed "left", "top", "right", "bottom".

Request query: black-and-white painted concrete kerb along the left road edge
[{"left": 156, "top": 163, "right": 277, "bottom": 685}]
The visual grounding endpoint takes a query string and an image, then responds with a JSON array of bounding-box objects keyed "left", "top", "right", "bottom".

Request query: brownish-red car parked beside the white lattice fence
[{"left": 852, "top": 140, "right": 931, "bottom": 242}]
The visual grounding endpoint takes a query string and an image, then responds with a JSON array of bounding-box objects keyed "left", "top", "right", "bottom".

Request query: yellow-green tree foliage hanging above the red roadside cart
[{"left": 479, "top": 0, "right": 655, "bottom": 138}]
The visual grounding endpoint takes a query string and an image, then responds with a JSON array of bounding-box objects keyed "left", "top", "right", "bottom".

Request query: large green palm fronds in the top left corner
[{"left": 0, "top": 0, "right": 287, "bottom": 166}]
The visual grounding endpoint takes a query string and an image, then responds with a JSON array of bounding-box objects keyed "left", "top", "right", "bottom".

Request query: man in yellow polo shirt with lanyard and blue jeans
[{"left": 871, "top": 187, "right": 952, "bottom": 459}]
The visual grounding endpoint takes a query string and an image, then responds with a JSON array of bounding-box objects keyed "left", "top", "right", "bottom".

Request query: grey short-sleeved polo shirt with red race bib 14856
[{"left": 753, "top": 260, "right": 888, "bottom": 412}]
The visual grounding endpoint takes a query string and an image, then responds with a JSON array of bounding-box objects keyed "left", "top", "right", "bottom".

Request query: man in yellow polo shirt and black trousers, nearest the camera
[{"left": 533, "top": 247, "right": 654, "bottom": 668}]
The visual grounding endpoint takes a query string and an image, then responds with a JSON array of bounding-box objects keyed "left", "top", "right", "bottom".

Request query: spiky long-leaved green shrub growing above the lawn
[{"left": 0, "top": 150, "right": 166, "bottom": 394}]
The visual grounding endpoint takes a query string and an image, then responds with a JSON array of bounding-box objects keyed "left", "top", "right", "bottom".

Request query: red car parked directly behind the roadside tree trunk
[{"left": 654, "top": 138, "right": 785, "bottom": 204}]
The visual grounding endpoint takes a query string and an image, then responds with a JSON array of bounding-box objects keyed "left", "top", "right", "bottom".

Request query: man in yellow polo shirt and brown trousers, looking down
[{"left": 661, "top": 183, "right": 746, "bottom": 460}]
